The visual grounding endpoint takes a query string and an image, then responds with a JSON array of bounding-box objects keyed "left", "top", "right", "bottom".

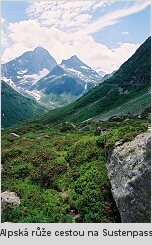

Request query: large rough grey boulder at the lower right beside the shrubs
[{"left": 106, "top": 132, "right": 151, "bottom": 223}]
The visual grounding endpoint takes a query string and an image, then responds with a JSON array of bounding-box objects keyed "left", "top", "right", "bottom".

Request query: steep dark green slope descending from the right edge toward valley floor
[{"left": 19, "top": 37, "right": 151, "bottom": 128}]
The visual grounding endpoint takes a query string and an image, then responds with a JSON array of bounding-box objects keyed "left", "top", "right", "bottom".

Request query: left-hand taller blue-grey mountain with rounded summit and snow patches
[{"left": 1, "top": 47, "right": 57, "bottom": 96}]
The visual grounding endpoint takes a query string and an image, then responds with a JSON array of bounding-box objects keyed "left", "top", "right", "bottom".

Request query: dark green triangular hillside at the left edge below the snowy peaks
[{"left": 1, "top": 81, "right": 46, "bottom": 128}]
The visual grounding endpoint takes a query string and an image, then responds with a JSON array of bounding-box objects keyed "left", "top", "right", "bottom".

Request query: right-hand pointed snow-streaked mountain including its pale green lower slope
[{"left": 30, "top": 55, "right": 101, "bottom": 107}]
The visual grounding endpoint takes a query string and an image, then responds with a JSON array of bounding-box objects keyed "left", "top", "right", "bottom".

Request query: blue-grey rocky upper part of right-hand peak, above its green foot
[{"left": 31, "top": 55, "right": 101, "bottom": 97}]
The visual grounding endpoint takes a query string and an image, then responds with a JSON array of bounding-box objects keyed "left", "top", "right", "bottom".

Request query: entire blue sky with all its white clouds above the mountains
[{"left": 1, "top": 1, "right": 151, "bottom": 73}]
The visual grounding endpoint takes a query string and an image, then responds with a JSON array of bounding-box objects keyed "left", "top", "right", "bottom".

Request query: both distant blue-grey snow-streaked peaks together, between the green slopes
[{"left": 1, "top": 47, "right": 103, "bottom": 109}]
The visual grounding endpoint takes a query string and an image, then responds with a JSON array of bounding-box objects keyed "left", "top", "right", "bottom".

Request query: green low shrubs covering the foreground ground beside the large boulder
[{"left": 1, "top": 119, "right": 149, "bottom": 223}]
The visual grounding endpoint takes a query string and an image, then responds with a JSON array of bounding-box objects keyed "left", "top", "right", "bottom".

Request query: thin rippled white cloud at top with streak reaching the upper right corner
[{"left": 27, "top": 1, "right": 151, "bottom": 33}]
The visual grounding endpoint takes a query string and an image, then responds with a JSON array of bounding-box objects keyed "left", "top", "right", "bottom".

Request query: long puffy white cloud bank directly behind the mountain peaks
[{"left": 3, "top": 20, "right": 139, "bottom": 73}]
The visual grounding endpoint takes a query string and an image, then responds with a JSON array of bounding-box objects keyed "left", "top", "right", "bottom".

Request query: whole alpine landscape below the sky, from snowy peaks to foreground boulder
[{"left": 1, "top": 37, "right": 151, "bottom": 223}]
